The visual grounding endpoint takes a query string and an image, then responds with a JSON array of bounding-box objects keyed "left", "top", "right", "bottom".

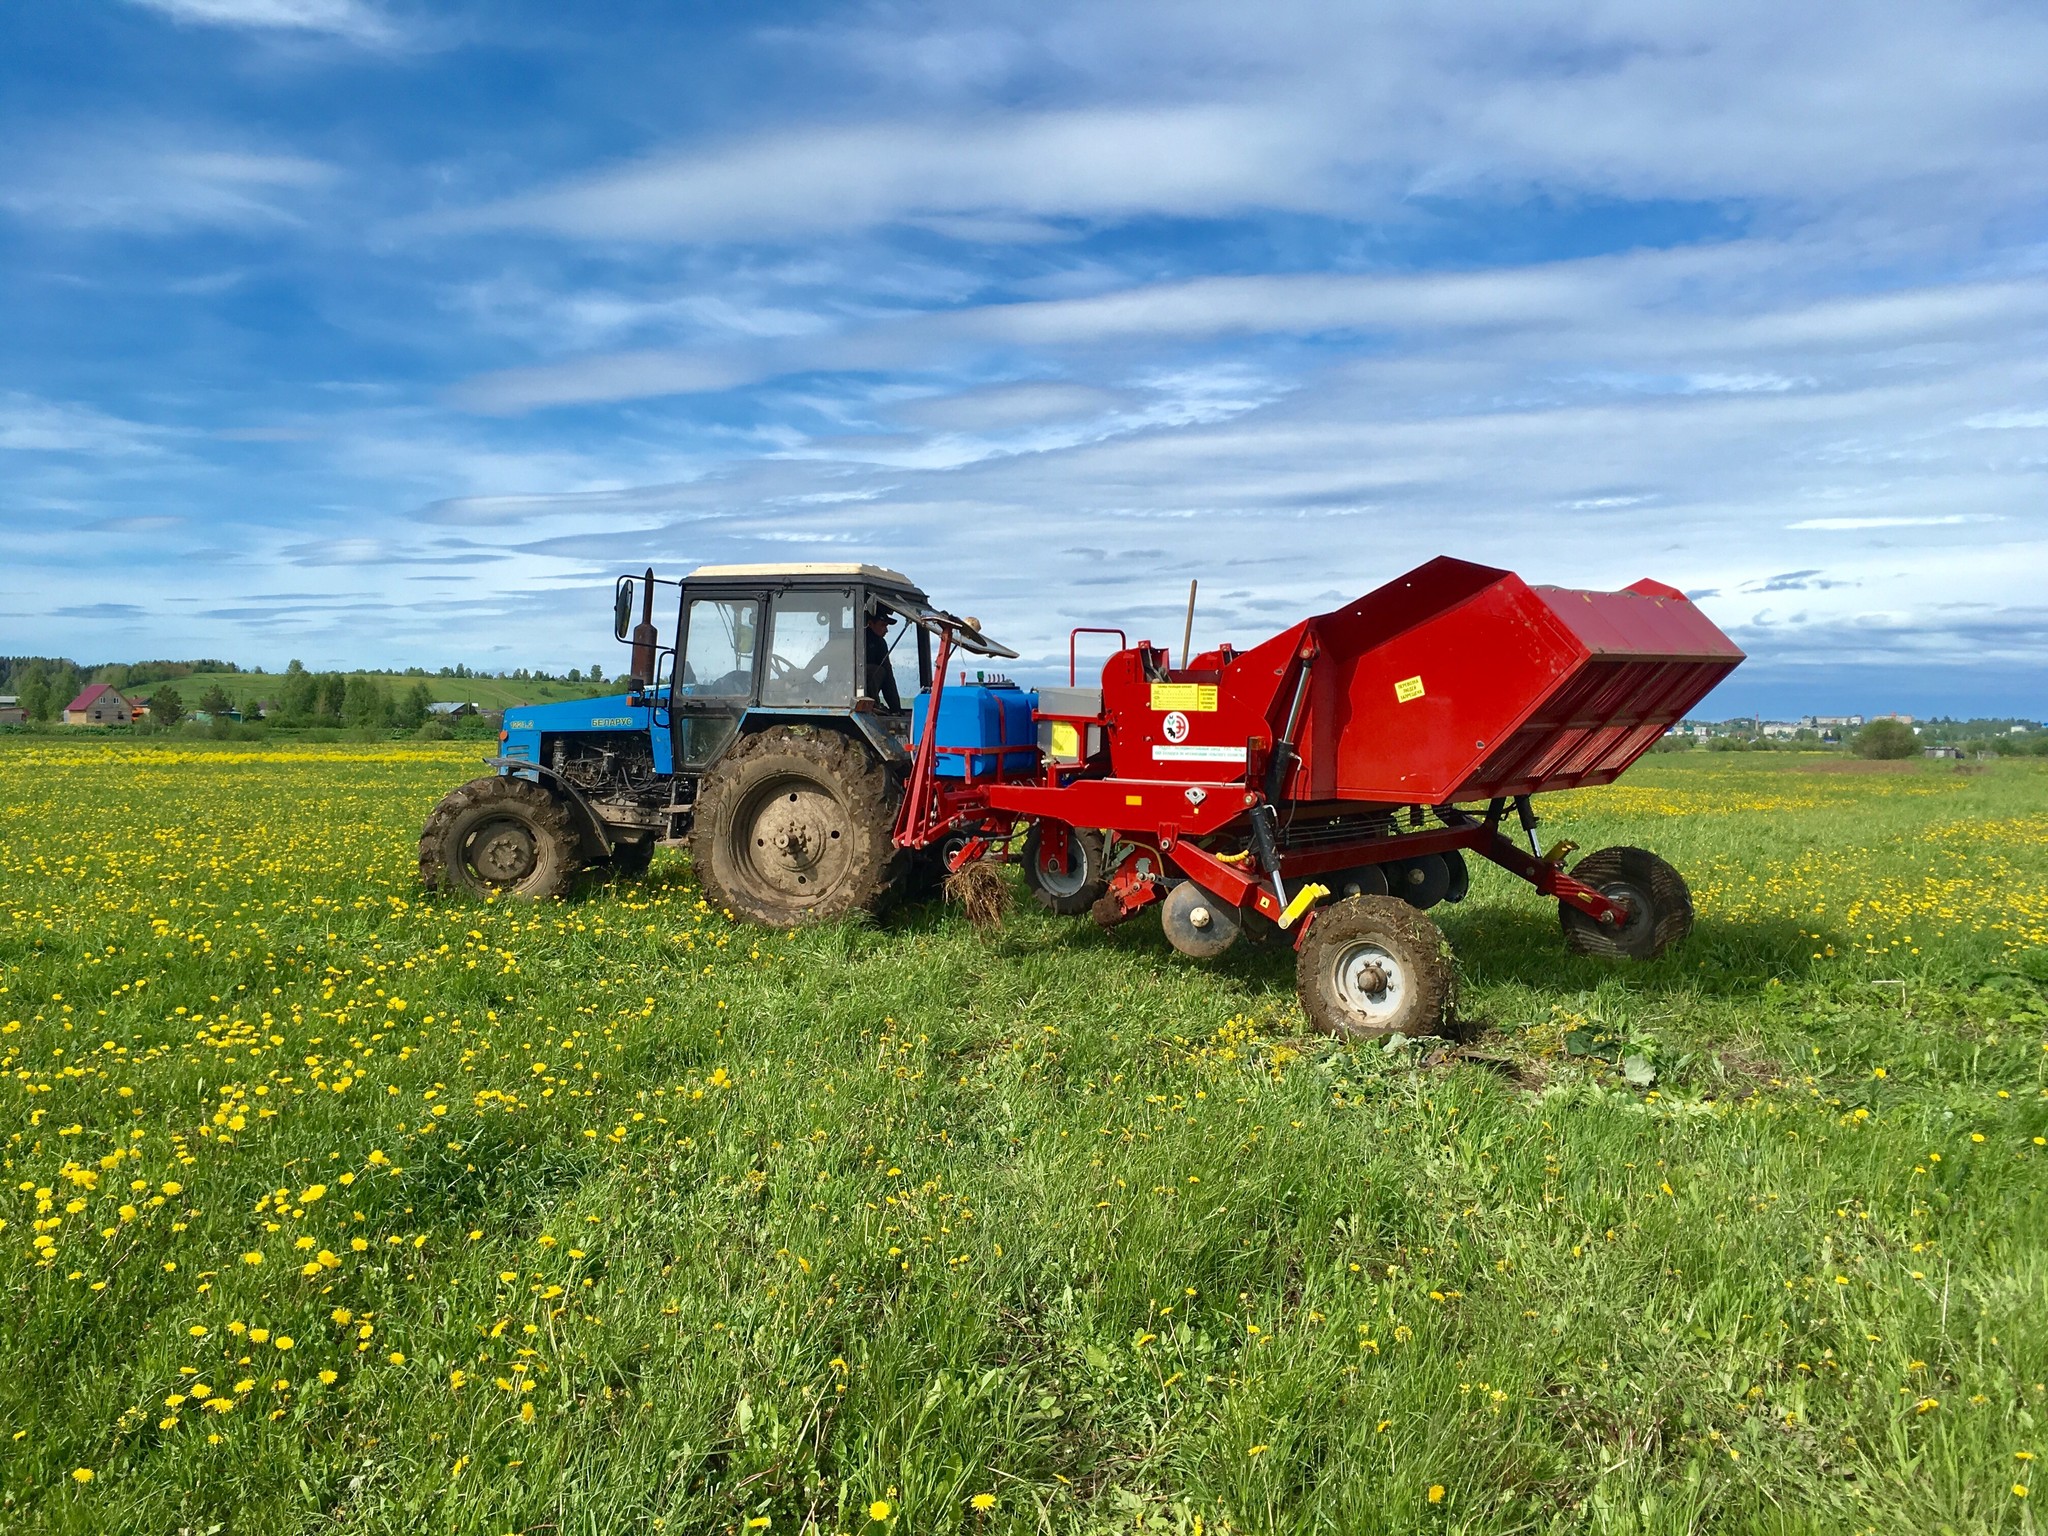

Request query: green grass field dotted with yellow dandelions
[{"left": 0, "top": 739, "right": 2048, "bottom": 1536}]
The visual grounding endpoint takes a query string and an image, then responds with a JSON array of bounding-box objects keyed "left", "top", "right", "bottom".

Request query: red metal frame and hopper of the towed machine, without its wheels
[{"left": 897, "top": 559, "right": 1743, "bottom": 932}]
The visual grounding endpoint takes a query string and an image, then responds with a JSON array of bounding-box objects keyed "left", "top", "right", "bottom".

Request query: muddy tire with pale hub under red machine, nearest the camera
[{"left": 1294, "top": 895, "right": 1458, "bottom": 1040}]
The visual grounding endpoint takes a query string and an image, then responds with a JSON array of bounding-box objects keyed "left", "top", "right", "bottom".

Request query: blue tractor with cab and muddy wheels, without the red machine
[{"left": 420, "top": 565, "right": 1030, "bottom": 928}]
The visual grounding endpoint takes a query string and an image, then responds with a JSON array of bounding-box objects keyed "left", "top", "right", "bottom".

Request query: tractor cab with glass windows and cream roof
[{"left": 638, "top": 563, "right": 932, "bottom": 772}]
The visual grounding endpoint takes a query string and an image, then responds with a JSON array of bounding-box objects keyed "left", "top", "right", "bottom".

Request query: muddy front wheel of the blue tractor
[{"left": 420, "top": 774, "right": 582, "bottom": 901}]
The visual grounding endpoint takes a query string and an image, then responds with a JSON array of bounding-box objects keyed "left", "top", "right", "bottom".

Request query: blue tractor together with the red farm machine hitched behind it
[{"left": 420, "top": 557, "right": 1743, "bottom": 1036}]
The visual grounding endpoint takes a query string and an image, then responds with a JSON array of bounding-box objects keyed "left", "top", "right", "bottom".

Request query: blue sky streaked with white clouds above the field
[{"left": 0, "top": 0, "right": 2048, "bottom": 715}]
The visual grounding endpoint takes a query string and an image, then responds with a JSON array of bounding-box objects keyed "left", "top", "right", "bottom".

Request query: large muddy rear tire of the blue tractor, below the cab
[{"left": 690, "top": 725, "right": 907, "bottom": 928}]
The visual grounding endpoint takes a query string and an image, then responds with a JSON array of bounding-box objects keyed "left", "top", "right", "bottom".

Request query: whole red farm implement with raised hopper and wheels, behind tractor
[{"left": 895, "top": 559, "right": 1743, "bottom": 1034}]
